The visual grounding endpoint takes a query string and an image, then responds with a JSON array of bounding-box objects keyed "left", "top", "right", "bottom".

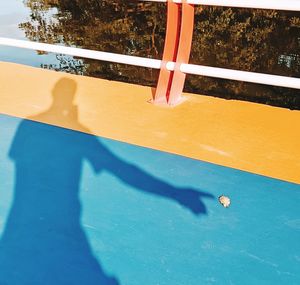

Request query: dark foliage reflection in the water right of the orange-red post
[{"left": 187, "top": 7, "right": 300, "bottom": 108}]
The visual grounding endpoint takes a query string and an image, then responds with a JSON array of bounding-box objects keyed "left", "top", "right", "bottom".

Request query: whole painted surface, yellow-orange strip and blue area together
[{"left": 0, "top": 63, "right": 300, "bottom": 285}]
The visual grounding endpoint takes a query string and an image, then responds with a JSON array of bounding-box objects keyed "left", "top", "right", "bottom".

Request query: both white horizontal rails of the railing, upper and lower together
[{"left": 0, "top": 0, "right": 300, "bottom": 89}]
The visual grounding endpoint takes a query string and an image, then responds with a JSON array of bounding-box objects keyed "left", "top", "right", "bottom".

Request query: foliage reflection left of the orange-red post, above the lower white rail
[{"left": 21, "top": 0, "right": 165, "bottom": 56}]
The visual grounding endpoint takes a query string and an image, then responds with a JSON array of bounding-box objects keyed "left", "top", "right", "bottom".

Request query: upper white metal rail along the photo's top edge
[{"left": 141, "top": 0, "right": 300, "bottom": 11}]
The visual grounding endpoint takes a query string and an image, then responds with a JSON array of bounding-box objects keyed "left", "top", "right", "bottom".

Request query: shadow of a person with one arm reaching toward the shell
[{"left": 0, "top": 78, "right": 213, "bottom": 285}]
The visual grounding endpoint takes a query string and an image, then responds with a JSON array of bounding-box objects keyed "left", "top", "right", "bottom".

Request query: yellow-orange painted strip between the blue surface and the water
[{"left": 0, "top": 62, "right": 300, "bottom": 184}]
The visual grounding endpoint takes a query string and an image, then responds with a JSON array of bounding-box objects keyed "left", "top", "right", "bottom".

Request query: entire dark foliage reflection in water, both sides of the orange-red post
[{"left": 21, "top": 0, "right": 300, "bottom": 108}]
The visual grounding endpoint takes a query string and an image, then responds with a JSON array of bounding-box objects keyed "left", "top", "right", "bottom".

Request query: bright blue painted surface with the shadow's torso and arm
[{"left": 0, "top": 114, "right": 300, "bottom": 285}]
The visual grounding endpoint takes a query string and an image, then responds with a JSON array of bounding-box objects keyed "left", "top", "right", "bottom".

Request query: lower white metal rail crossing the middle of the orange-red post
[{"left": 0, "top": 37, "right": 300, "bottom": 89}]
